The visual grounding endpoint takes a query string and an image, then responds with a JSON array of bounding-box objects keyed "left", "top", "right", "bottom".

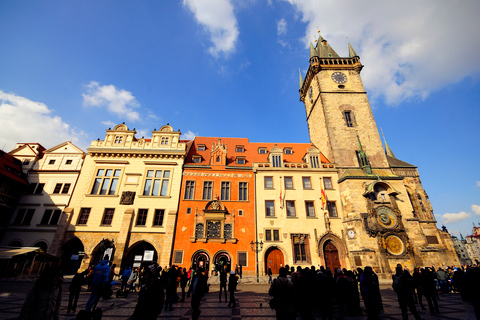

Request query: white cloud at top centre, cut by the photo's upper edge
[{"left": 183, "top": 0, "right": 239, "bottom": 57}]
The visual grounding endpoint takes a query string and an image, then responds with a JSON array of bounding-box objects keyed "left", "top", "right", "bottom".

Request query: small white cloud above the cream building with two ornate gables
[{"left": 82, "top": 81, "right": 140, "bottom": 121}]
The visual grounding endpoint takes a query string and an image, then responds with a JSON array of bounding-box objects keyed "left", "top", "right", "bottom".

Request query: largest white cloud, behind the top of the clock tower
[{"left": 284, "top": 0, "right": 480, "bottom": 104}]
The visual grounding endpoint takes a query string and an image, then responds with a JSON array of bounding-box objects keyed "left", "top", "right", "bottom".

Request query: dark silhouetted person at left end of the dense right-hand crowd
[{"left": 268, "top": 267, "right": 297, "bottom": 320}]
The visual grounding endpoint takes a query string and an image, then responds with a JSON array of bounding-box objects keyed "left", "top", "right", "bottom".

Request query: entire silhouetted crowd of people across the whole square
[{"left": 15, "top": 256, "right": 480, "bottom": 320}]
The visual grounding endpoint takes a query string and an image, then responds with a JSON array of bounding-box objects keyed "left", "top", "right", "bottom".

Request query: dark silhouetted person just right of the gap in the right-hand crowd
[{"left": 392, "top": 264, "right": 422, "bottom": 320}]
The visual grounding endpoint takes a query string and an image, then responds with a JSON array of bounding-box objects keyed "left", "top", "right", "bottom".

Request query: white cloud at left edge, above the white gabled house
[{"left": 0, "top": 90, "right": 88, "bottom": 152}]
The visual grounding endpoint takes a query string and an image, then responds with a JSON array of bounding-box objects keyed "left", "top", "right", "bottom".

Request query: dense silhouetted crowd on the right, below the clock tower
[{"left": 267, "top": 264, "right": 480, "bottom": 320}]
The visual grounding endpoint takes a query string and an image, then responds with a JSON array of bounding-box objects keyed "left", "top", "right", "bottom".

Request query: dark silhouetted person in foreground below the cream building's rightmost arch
[{"left": 130, "top": 264, "right": 165, "bottom": 320}]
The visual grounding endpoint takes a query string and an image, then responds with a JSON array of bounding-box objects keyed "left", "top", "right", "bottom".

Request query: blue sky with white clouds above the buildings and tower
[{"left": 0, "top": 0, "right": 480, "bottom": 235}]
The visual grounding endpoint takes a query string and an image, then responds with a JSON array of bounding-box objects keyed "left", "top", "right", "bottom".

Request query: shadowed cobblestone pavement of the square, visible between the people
[{"left": 0, "top": 277, "right": 475, "bottom": 320}]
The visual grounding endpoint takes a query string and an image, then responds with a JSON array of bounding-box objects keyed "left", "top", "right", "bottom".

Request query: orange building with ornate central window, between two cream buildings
[{"left": 172, "top": 137, "right": 256, "bottom": 274}]
